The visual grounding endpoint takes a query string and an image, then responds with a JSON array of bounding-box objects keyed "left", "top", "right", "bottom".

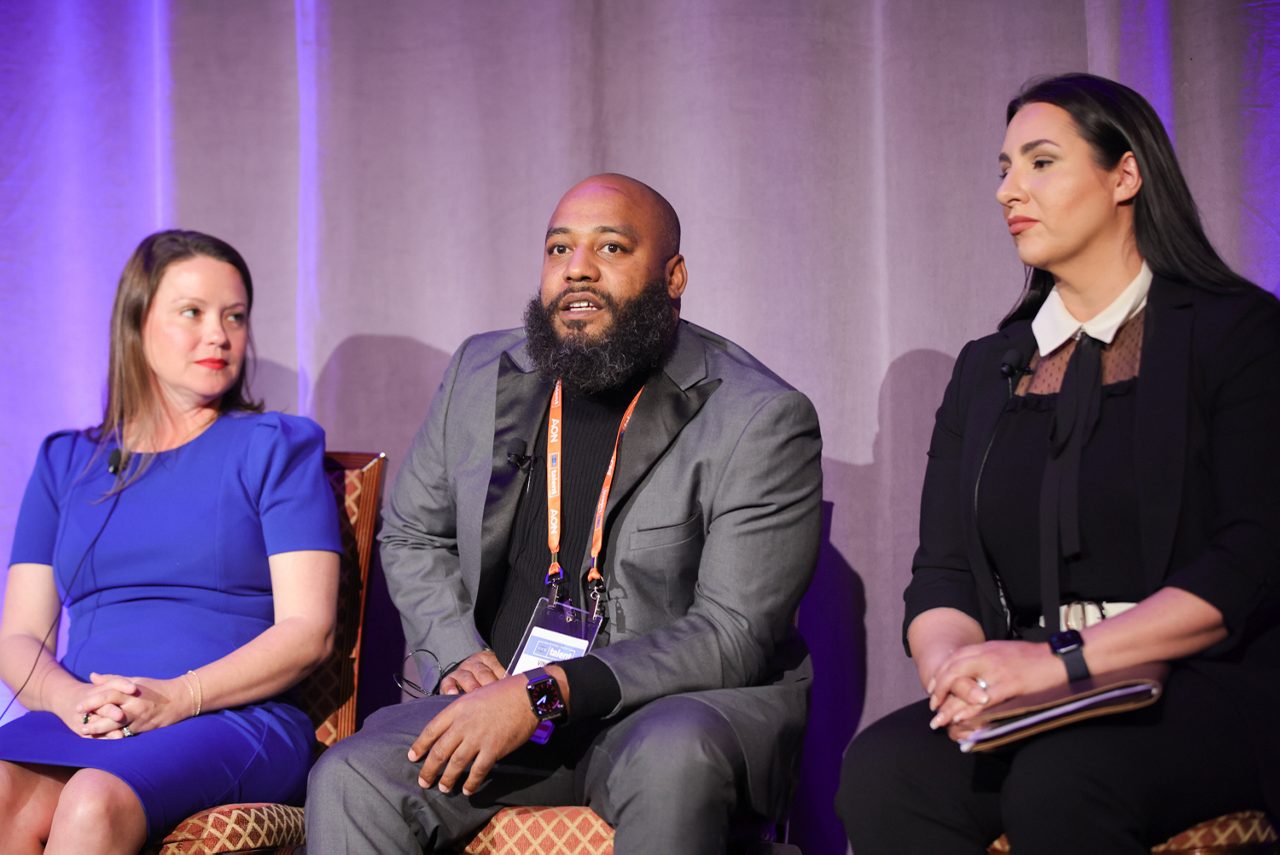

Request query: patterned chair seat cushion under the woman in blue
[{"left": 159, "top": 804, "right": 306, "bottom": 855}]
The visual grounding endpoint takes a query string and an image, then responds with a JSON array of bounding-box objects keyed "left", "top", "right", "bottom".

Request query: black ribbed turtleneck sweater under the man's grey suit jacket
[{"left": 479, "top": 381, "right": 641, "bottom": 719}]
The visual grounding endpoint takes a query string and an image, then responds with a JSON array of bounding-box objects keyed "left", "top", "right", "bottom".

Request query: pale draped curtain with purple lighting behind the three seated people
[{"left": 0, "top": 0, "right": 1280, "bottom": 851}]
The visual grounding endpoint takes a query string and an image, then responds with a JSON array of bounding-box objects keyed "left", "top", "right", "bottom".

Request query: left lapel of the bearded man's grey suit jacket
[{"left": 479, "top": 348, "right": 550, "bottom": 600}]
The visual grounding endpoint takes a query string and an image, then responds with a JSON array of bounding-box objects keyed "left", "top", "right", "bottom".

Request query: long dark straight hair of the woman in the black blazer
[{"left": 1000, "top": 73, "right": 1256, "bottom": 329}]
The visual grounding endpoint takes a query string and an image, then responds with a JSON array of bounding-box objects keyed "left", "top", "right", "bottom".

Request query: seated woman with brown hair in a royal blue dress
[{"left": 0, "top": 230, "right": 340, "bottom": 855}]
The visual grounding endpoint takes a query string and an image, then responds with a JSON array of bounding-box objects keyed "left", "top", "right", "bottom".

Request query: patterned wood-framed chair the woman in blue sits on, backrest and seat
[{"left": 150, "top": 452, "right": 387, "bottom": 855}]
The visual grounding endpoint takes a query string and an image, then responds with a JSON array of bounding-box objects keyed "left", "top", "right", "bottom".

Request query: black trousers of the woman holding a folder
[{"left": 836, "top": 668, "right": 1263, "bottom": 855}]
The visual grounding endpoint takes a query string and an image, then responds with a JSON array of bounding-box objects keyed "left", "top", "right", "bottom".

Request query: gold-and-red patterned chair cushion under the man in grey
[{"left": 463, "top": 806, "right": 613, "bottom": 855}]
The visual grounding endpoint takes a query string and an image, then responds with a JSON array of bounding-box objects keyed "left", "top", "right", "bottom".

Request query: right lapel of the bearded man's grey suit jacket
[{"left": 605, "top": 324, "right": 721, "bottom": 518}]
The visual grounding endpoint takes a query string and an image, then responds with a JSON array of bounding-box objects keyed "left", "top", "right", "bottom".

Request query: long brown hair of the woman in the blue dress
[{"left": 95, "top": 229, "right": 262, "bottom": 471}]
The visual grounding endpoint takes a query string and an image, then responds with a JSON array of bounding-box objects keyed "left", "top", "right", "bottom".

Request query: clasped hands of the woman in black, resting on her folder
[{"left": 924, "top": 641, "right": 1066, "bottom": 742}]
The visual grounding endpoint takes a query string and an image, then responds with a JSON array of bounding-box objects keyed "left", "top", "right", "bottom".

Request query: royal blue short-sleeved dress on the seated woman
[{"left": 0, "top": 412, "right": 342, "bottom": 837}]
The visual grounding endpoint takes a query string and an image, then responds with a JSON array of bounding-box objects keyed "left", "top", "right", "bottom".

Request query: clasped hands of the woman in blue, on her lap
[{"left": 63, "top": 673, "right": 191, "bottom": 739}]
